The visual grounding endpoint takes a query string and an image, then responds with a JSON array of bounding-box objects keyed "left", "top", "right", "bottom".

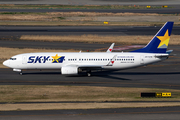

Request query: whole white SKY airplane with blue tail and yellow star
[{"left": 3, "top": 22, "right": 174, "bottom": 76}]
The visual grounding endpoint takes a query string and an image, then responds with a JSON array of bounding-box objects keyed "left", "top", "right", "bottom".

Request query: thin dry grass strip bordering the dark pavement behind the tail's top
[{"left": 0, "top": 21, "right": 172, "bottom": 26}]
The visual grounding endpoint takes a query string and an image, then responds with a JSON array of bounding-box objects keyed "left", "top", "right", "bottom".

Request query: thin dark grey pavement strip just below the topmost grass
[{"left": 0, "top": 5, "right": 180, "bottom": 14}]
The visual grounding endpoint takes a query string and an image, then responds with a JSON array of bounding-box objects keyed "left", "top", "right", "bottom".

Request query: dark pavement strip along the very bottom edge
[{"left": 0, "top": 107, "right": 180, "bottom": 120}]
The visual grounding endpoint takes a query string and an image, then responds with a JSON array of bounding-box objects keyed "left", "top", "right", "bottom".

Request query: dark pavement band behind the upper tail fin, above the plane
[{"left": 0, "top": 26, "right": 180, "bottom": 37}]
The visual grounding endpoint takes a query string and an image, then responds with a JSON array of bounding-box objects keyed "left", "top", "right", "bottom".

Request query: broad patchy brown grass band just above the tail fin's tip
[{"left": 0, "top": 12, "right": 180, "bottom": 26}]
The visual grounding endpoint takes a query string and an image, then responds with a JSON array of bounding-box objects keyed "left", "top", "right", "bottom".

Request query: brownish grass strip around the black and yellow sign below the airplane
[{"left": 0, "top": 85, "right": 180, "bottom": 103}]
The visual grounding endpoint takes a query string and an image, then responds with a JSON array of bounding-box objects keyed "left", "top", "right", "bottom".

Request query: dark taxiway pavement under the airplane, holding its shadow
[{"left": 0, "top": 65, "right": 180, "bottom": 89}]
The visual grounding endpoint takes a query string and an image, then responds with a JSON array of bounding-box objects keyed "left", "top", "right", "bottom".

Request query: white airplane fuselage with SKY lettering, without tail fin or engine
[{"left": 3, "top": 52, "right": 167, "bottom": 70}]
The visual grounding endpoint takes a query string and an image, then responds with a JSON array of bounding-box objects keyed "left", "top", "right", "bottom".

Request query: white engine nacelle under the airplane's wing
[{"left": 61, "top": 66, "right": 78, "bottom": 75}]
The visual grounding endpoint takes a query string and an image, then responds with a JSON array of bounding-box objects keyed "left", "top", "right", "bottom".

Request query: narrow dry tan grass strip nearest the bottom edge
[{"left": 0, "top": 102, "right": 180, "bottom": 111}]
